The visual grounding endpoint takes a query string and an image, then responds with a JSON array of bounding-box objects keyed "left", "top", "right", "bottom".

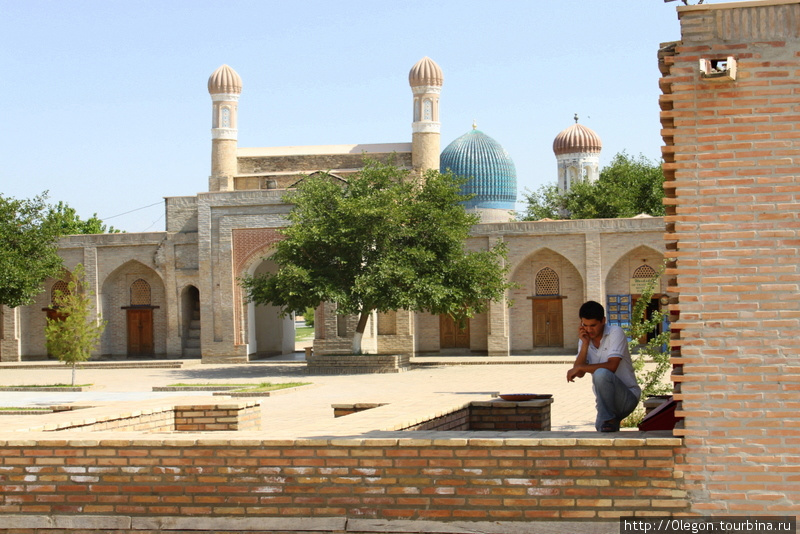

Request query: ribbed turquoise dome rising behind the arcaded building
[{"left": 439, "top": 129, "right": 517, "bottom": 210}]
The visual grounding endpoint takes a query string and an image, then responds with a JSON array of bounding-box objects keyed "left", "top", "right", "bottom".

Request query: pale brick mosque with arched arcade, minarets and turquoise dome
[{"left": 0, "top": 57, "right": 666, "bottom": 363}]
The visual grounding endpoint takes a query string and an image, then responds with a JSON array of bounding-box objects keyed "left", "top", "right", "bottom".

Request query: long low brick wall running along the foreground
[{"left": 0, "top": 434, "right": 688, "bottom": 531}]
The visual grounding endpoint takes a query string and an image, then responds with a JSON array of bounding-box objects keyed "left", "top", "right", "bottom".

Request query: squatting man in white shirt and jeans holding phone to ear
[{"left": 567, "top": 300, "right": 642, "bottom": 432}]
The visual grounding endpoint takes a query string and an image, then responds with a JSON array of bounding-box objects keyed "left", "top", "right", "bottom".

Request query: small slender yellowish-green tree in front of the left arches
[{"left": 44, "top": 264, "right": 106, "bottom": 386}]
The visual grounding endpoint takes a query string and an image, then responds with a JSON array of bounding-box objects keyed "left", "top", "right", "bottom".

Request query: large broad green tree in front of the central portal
[{"left": 242, "top": 160, "right": 510, "bottom": 354}]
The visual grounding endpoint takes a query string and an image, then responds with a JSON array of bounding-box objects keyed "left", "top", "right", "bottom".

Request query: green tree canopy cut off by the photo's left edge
[{"left": 0, "top": 193, "right": 61, "bottom": 308}]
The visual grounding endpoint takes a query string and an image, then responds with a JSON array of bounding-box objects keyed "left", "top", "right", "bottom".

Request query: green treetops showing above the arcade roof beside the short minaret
[{"left": 523, "top": 152, "right": 665, "bottom": 221}]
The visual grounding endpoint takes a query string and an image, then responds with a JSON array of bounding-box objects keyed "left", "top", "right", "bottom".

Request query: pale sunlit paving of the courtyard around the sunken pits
[{"left": 0, "top": 354, "right": 612, "bottom": 438}]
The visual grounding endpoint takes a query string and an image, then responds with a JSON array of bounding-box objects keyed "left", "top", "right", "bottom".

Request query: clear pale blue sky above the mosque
[{"left": 0, "top": 0, "right": 692, "bottom": 232}]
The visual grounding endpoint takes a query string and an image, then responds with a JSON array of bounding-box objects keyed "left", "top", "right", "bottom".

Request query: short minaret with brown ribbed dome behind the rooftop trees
[{"left": 553, "top": 113, "right": 603, "bottom": 191}]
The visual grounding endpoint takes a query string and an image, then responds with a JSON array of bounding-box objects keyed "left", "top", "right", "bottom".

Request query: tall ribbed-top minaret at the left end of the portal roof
[{"left": 208, "top": 65, "right": 242, "bottom": 191}]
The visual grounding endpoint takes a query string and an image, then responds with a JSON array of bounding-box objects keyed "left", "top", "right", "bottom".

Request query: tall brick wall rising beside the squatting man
[{"left": 660, "top": 0, "right": 800, "bottom": 515}]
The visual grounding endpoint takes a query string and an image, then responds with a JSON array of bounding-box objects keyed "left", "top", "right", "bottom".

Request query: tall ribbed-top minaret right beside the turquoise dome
[{"left": 408, "top": 56, "right": 444, "bottom": 172}]
